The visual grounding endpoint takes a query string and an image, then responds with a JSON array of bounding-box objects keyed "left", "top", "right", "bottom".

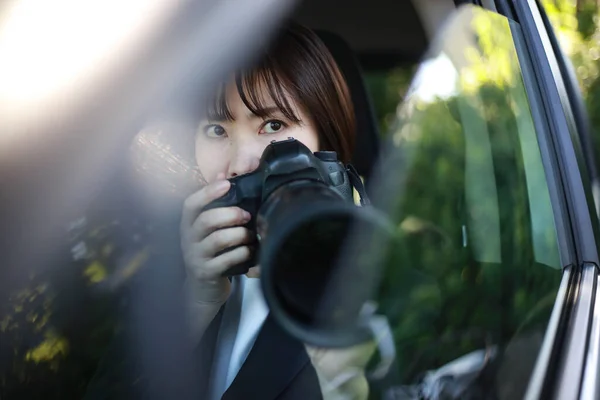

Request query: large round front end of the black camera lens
[{"left": 257, "top": 182, "right": 394, "bottom": 347}]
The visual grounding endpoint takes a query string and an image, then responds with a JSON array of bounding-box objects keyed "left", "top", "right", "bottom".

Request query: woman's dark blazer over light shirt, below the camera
[{"left": 197, "top": 309, "right": 323, "bottom": 400}]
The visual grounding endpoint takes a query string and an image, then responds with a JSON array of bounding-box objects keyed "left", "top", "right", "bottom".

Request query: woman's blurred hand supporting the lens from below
[{"left": 305, "top": 341, "right": 377, "bottom": 400}]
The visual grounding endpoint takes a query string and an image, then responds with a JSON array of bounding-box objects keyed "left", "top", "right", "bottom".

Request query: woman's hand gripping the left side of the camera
[{"left": 180, "top": 174, "right": 252, "bottom": 302}]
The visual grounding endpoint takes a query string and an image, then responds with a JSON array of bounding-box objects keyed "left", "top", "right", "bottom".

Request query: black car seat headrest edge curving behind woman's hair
[{"left": 316, "top": 30, "right": 379, "bottom": 180}]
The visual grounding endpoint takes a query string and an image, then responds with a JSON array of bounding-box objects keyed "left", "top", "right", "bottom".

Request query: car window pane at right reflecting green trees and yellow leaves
[{"left": 358, "top": 7, "right": 562, "bottom": 399}]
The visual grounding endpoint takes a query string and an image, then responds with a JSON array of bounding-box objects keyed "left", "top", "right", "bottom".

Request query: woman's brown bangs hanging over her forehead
[{"left": 207, "top": 62, "right": 301, "bottom": 123}]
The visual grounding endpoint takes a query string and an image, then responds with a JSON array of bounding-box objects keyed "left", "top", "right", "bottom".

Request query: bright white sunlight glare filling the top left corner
[{"left": 0, "top": 0, "right": 174, "bottom": 145}]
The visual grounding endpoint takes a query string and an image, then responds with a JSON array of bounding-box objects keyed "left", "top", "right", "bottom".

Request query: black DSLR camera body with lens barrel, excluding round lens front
[{"left": 205, "top": 138, "right": 354, "bottom": 276}]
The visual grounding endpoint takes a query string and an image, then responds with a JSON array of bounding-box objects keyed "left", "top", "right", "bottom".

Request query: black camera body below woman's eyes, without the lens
[{"left": 205, "top": 138, "right": 354, "bottom": 276}]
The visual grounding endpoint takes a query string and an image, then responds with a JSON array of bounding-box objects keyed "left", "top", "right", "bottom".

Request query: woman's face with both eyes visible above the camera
[{"left": 196, "top": 84, "right": 319, "bottom": 183}]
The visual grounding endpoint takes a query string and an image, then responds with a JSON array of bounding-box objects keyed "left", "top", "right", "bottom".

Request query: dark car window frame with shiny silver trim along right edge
[{"left": 486, "top": 0, "right": 600, "bottom": 399}]
